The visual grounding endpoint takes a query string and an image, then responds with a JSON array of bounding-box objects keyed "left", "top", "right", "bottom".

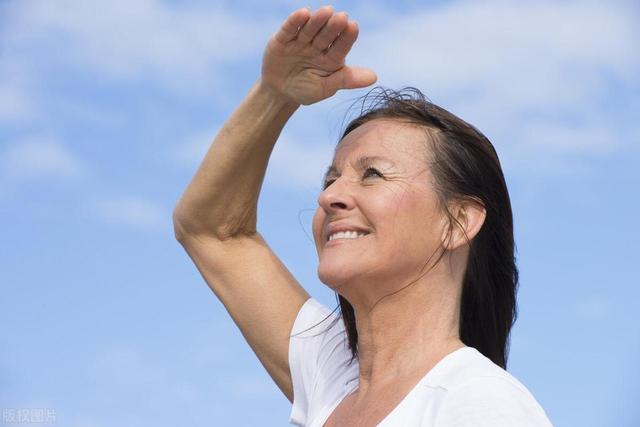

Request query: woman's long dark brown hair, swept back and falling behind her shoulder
[{"left": 336, "top": 87, "right": 518, "bottom": 369}]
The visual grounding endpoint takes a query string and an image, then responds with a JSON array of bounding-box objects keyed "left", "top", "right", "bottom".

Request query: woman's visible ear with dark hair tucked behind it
[{"left": 442, "top": 198, "right": 487, "bottom": 251}]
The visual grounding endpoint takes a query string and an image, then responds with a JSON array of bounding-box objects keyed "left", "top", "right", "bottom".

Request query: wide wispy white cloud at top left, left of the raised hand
[{"left": 5, "top": 0, "right": 275, "bottom": 86}]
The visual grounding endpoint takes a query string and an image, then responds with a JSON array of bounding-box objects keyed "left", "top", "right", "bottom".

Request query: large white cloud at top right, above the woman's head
[{"left": 350, "top": 1, "right": 640, "bottom": 161}]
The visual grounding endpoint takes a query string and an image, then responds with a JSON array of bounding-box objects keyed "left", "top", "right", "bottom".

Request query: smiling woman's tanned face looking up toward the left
[{"left": 313, "top": 119, "right": 445, "bottom": 301}]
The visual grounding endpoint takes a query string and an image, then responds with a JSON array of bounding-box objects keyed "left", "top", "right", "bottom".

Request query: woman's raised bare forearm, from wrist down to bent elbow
[{"left": 173, "top": 81, "right": 298, "bottom": 239}]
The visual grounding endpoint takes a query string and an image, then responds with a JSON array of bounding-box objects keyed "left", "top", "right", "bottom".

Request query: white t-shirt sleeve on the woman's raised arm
[{"left": 289, "top": 298, "right": 357, "bottom": 426}]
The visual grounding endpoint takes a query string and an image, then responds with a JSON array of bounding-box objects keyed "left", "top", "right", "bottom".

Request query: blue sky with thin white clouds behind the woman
[{"left": 0, "top": 0, "right": 640, "bottom": 427}]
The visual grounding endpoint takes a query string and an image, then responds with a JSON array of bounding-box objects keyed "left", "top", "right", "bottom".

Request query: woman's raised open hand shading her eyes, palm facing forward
[{"left": 262, "top": 6, "right": 377, "bottom": 105}]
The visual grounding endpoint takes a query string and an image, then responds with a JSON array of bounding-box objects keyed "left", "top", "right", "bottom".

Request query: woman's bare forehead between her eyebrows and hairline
[{"left": 333, "top": 119, "right": 430, "bottom": 169}]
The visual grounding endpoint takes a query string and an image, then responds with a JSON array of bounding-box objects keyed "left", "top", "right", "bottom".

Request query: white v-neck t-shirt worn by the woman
[{"left": 289, "top": 298, "right": 551, "bottom": 427}]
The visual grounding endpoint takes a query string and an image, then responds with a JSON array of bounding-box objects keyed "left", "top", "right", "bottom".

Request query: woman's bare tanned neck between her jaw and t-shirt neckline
[{"left": 352, "top": 275, "right": 464, "bottom": 391}]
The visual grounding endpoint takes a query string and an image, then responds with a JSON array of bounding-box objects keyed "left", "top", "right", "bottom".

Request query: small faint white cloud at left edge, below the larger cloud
[{"left": 0, "top": 137, "right": 87, "bottom": 181}]
